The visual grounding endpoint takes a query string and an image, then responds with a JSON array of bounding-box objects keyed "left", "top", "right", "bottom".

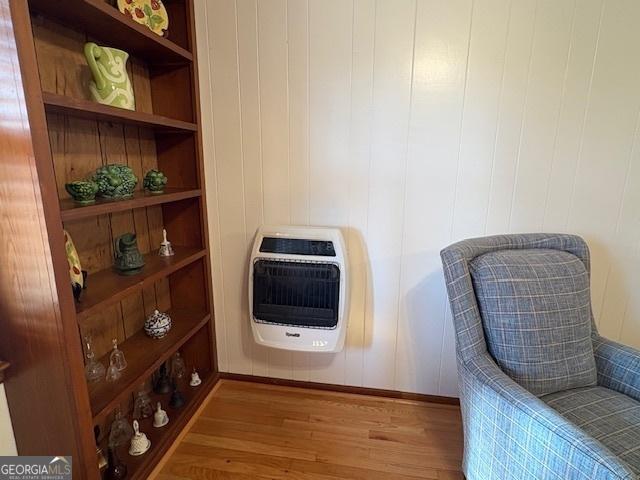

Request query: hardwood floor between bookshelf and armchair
[{"left": 156, "top": 380, "right": 463, "bottom": 480}]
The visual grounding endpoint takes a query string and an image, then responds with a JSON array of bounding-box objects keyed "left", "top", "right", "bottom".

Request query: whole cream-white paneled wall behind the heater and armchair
[{"left": 196, "top": 0, "right": 640, "bottom": 395}]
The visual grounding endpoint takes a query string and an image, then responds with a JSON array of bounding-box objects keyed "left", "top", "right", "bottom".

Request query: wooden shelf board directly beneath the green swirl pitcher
[{"left": 42, "top": 92, "right": 198, "bottom": 132}]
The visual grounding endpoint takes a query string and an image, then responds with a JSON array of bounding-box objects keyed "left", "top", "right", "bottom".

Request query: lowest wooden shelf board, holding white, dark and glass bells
[{"left": 102, "top": 372, "right": 218, "bottom": 480}]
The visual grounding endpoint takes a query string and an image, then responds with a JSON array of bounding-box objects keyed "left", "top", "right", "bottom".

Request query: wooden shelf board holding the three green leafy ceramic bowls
[{"left": 60, "top": 188, "right": 201, "bottom": 222}]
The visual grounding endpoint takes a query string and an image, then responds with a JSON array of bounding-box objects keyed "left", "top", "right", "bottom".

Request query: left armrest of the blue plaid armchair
[{"left": 459, "top": 353, "right": 636, "bottom": 480}]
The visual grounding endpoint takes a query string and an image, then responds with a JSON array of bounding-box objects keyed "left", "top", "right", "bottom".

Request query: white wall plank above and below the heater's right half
[{"left": 307, "top": 0, "right": 353, "bottom": 383}]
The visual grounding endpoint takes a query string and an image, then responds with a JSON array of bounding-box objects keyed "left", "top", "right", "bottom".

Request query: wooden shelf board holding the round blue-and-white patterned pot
[{"left": 89, "top": 309, "right": 210, "bottom": 424}]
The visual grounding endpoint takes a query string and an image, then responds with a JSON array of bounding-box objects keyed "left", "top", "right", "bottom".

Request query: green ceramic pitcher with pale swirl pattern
[{"left": 84, "top": 42, "right": 136, "bottom": 110}]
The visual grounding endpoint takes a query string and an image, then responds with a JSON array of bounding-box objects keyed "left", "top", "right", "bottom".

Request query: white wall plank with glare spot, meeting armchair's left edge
[{"left": 395, "top": 0, "right": 471, "bottom": 392}]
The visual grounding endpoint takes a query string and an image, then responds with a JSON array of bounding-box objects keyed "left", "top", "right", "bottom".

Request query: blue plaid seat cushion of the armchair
[{"left": 541, "top": 386, "right": 640, "bottom": 475}]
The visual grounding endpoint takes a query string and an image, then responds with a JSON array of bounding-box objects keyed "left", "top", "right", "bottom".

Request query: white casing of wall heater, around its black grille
[{"left": 249, "top": 226, "right": 349, "bottom": 352}]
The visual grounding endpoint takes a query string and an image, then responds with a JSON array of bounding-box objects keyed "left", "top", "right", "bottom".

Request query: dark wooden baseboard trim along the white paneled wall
[{"left": 220, "top": 372, "right": 460, "bottom": 405}]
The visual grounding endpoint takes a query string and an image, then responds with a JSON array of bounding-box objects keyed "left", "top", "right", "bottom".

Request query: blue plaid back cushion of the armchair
[{"left": 469, "top": 248, "right": 597, "bottom": 395}]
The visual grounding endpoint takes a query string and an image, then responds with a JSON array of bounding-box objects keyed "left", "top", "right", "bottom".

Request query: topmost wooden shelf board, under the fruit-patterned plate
[{"left": 29, "top": 0, "right": 193, "bottom": 65}]
